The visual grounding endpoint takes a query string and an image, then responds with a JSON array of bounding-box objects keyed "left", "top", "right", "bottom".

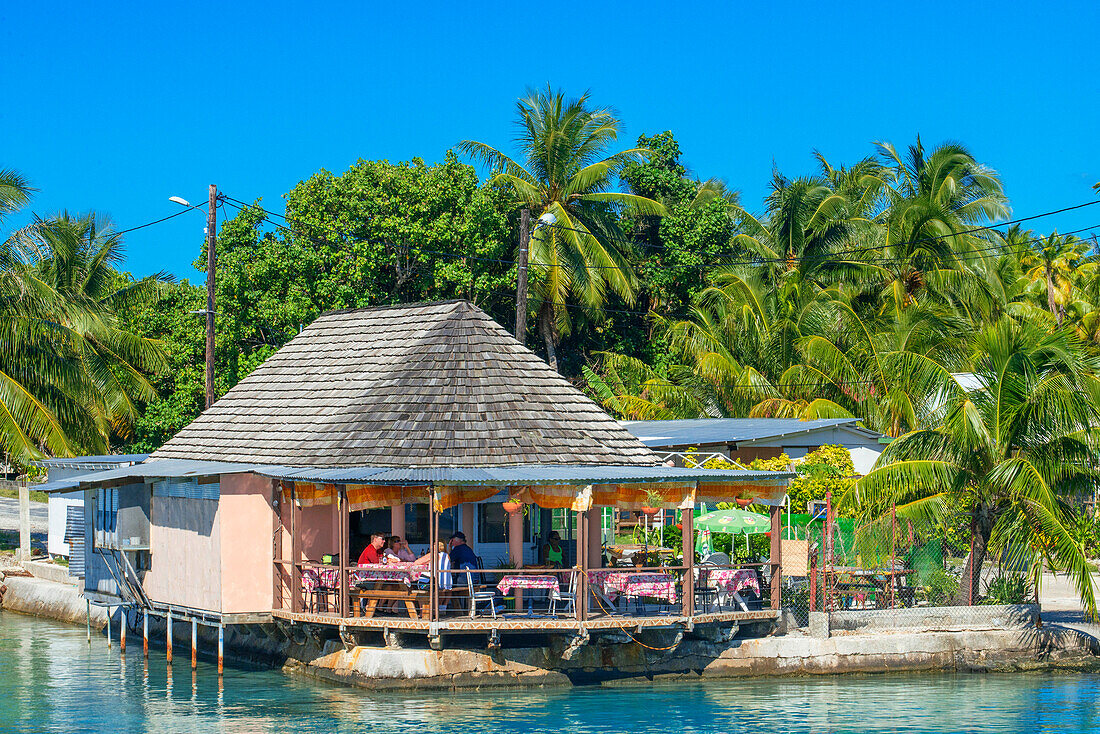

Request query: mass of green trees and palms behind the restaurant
[{"left": 12, "top": 87, "right": 1100, "bottom": 609}]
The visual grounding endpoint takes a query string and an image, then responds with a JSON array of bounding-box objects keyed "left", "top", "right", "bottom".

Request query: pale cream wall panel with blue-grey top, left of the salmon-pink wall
[{"left": 144, "top": 496, "right": 223, "bottom": 612}]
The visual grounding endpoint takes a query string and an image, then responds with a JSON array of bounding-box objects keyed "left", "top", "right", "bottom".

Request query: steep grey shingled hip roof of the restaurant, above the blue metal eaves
[{"left": 151, "top": 300, "right": 661, "bottom": 467}]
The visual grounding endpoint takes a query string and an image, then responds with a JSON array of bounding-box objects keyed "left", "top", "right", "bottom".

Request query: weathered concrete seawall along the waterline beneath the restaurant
[{"left": 0, "top": 577, "right": 1100, "bottom": 690}]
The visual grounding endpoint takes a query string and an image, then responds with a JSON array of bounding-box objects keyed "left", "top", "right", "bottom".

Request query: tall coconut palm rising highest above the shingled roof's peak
[{"left": 459, "top": 86, "right": 664, "bottom": 370}]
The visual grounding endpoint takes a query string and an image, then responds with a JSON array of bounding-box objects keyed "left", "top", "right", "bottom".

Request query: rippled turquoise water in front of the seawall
[{"left": 0, "top": 613, "right": 1100, "bottom": 734}]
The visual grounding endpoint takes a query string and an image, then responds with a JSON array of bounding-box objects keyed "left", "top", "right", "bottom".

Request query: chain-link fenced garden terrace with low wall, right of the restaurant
[{"left": 782, "top": 502, "right": 1032, "bottom": 629}]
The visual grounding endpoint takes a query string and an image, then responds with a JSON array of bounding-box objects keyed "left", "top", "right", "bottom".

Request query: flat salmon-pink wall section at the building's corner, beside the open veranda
[{"left": 218, "top": 474, "right": 275, "bottom": 614}]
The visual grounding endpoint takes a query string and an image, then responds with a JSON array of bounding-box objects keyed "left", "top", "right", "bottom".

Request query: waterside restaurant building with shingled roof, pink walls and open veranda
[{"left": 51, "top": 300, "right": 790, "bottom": 644}]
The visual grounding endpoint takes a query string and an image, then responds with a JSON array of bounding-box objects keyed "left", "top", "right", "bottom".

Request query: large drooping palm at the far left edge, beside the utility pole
[{"left": 0, "top": 172, "right": 163, "bottom": 461}]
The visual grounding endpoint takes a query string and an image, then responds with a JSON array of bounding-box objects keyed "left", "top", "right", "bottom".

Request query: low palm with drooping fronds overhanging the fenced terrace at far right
[{"left": 842, "top": 318, "right": 1100, "bottom": 617}]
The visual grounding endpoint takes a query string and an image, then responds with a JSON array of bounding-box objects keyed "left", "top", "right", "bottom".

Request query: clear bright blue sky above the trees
[{"left": 0, "top": 0, "right": 1100, "bottom": 281}]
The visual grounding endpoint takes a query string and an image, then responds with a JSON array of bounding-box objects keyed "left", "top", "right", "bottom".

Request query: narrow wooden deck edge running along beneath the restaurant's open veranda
[{"left": 272, "top": 610, "right": 779, "bottom": 634}]
